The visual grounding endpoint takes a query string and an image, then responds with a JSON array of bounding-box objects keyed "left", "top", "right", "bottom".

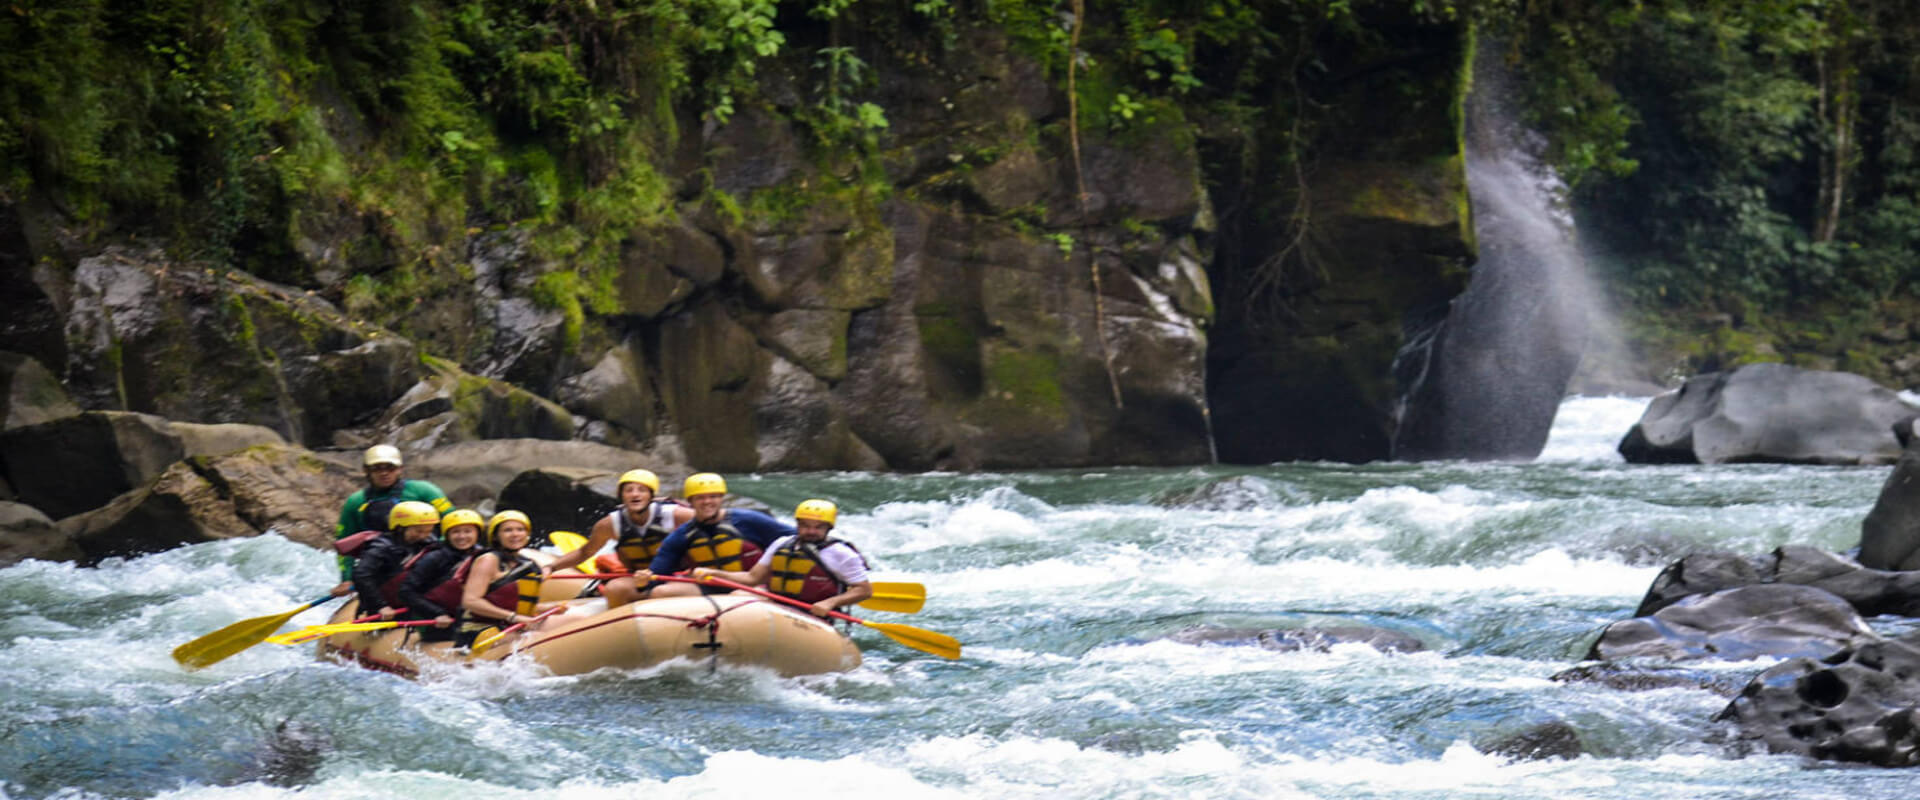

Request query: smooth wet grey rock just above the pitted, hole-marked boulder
[{"left": 1586, "top": 585, "right": 1878, "bottom": 662}]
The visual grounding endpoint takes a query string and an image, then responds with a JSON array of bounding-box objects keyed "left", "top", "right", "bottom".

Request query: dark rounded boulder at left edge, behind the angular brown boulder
[{"left": 0, "top": 411, "right": 284, "bottom": 518}]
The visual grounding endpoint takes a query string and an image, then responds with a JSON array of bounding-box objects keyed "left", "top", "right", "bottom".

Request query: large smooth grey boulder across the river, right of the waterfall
[{"left": 1620, "top": 365, "right": 1920, "bottom": 464}]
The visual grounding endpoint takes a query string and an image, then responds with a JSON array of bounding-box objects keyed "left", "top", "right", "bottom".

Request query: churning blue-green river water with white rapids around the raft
[{"left": 0, "top": 399, "right": 1914, "bottom": 800}]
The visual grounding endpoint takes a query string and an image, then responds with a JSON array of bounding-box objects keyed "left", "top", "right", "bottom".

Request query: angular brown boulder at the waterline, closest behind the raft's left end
[{"left": 58, "top": 445, "right": 357, "bottom": 564}]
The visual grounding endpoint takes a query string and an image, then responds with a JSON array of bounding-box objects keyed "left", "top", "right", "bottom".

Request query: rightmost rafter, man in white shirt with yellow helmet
[{"left": 693, "top": 501, "right": 874, "bottom": 616}]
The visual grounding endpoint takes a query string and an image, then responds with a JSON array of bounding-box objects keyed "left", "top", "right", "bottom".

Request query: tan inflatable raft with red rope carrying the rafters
[{"left": 319, "top": 581, "right": 860, "bottom": 677}]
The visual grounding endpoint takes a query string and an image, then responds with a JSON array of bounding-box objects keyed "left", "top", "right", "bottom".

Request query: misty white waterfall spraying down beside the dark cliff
[{"left": 1394, "top": 42, "right": 1597, "bottom": 460}]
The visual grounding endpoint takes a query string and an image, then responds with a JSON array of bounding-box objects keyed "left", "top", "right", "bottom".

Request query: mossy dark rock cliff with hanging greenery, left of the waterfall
[{"left": 0, "top": 4, "right": 1473, "bottom": 470}]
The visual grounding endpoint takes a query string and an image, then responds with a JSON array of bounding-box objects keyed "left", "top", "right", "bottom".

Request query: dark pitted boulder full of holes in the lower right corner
[{"left": 1715, "top": 641, "right": 1920, "bottom": 767}]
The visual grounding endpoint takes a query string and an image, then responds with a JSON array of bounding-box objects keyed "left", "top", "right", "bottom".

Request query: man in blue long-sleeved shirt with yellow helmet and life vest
[{"left": 647, "top": 472, "right": 795, "bottom": 597}]
